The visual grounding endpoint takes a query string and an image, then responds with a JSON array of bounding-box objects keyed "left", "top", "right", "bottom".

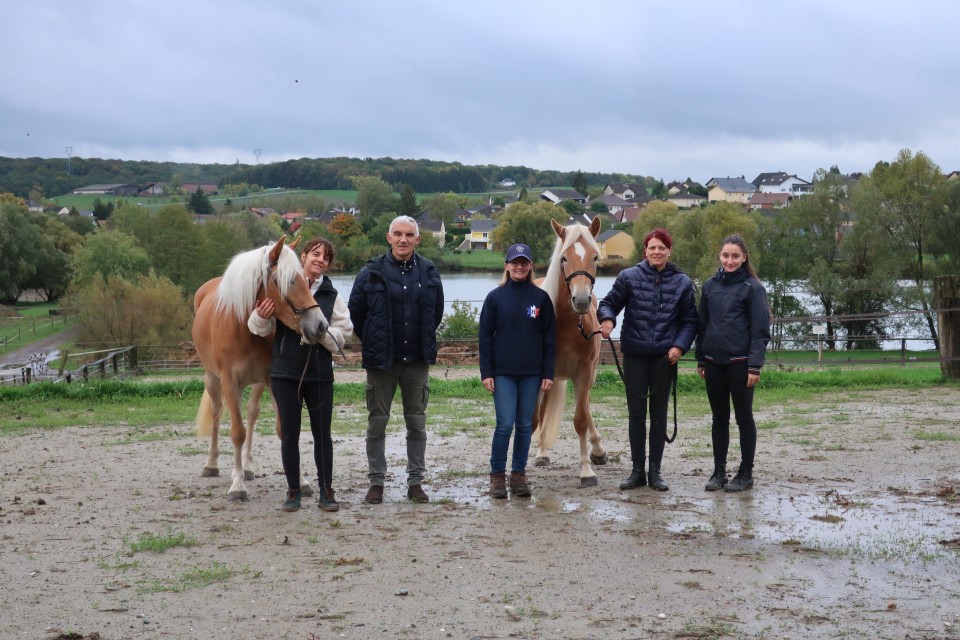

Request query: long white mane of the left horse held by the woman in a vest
[{"left": 217, "top": 243, "right": 302, "bottom": 322}]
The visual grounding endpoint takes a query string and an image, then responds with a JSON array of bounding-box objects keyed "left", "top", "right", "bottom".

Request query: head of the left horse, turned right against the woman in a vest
[{"left": 261, "top": 238, "right": 328, "bottom": 344}]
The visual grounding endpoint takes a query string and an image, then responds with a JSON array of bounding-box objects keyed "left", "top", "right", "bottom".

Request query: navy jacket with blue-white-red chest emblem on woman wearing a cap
[{"left": 480, "top": 280, "right": 557, "bottom": 380}]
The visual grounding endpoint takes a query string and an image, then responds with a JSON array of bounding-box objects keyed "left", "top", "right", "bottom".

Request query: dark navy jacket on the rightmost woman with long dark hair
[{"left": 695, "top": 267, "right": 770, "bottom": 374}]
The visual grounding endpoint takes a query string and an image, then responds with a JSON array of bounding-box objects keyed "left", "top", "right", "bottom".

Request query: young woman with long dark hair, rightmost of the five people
[{"left": 696, "top": 235, "right": 770, "bottom": 491}]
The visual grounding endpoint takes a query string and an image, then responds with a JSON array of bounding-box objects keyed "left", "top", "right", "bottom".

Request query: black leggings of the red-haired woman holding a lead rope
[{"left": 623, "top": 354, "right": 671, "bottom": 471}]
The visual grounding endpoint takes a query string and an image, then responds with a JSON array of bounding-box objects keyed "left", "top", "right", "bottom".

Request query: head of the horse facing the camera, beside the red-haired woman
[{"left": 550, "top": 217, "right": 600, "bottom": 315}]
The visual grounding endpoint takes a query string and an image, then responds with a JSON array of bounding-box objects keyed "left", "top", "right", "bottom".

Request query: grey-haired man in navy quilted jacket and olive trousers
[{"left": 347, "top": 216, "right": 443, "bottom": 504}]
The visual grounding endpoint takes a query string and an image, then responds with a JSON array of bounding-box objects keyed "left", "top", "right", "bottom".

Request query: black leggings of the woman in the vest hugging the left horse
[{"left": 270, "top": 378, "right": 333, "bottom": 489}]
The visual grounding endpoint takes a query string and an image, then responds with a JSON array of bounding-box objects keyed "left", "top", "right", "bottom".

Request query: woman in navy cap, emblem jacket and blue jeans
[{"left": 480, "top": 244, "right": 557, "bottom": 498}]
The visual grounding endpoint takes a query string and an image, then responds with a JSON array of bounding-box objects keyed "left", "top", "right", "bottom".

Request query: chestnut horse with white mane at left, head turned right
[{"left": 193, "top": 238, "right": 327, "bottom": 500}]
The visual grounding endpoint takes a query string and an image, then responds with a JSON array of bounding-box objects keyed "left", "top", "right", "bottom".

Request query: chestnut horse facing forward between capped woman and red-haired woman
[{"left": 533, "top": 218, "right": 607, "bottom": 487}]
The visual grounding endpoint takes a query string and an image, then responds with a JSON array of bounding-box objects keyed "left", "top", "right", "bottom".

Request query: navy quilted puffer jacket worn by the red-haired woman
[{"left": 597, "top": 260, "right": 697, "bottom": 356}]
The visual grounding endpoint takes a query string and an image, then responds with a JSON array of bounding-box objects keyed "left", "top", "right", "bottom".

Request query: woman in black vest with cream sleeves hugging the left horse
[{"left": 247, "top": 238, "right": 353, "bottom": 511}]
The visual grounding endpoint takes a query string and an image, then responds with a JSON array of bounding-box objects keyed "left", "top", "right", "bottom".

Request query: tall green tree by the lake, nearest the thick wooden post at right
[{"left": 855, "top": 149, "right": 948, "bottom": 349}]
